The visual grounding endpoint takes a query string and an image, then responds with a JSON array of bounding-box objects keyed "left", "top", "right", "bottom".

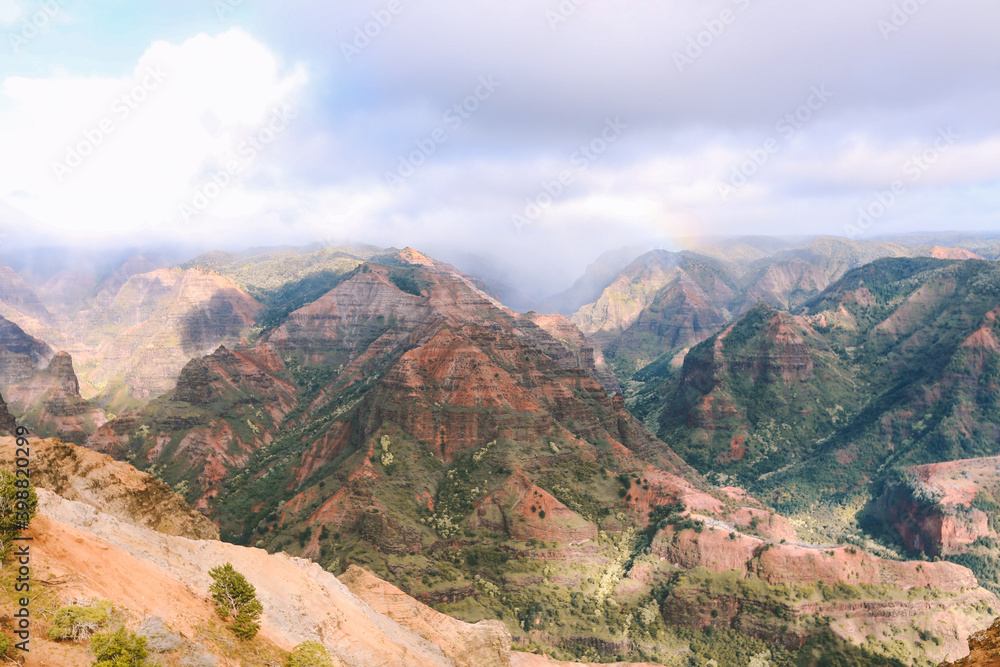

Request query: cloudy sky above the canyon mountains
[{"left": 0, "top": 0, "right": 1000, "bottom": 295}]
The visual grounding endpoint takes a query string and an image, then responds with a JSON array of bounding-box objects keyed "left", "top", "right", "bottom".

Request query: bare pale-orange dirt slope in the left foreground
[{"left": 30, "top": 489, "right": 510, "bottom": 667}]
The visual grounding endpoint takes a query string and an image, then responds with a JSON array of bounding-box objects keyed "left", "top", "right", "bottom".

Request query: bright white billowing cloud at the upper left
[{"left": 0, "top": 29, "right": 307, "bottom": 243}]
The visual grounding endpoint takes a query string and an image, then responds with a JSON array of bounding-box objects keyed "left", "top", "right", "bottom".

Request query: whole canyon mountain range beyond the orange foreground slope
[{"left": 0, "top": 237, "right": 1000, "bottom": 666}]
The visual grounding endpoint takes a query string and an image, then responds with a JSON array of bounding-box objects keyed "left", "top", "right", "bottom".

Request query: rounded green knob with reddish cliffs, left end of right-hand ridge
[{"left": 643, "top": 304, "right": 865, "bottom": 486}]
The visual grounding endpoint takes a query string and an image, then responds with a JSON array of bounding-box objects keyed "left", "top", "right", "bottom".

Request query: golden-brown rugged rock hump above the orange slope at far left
[{"left": 0, "top": 438, "right": 219, "bottom": 539}]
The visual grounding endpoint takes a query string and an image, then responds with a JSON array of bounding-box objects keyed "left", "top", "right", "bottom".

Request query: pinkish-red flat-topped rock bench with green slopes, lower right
[{"left": 651, "top": 508, "right": 1000, "bottom": 660}]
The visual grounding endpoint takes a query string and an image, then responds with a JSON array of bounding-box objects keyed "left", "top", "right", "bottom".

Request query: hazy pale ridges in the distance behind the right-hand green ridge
[{"left": 573, "top": 238, "right": 967, "bottom": 374}]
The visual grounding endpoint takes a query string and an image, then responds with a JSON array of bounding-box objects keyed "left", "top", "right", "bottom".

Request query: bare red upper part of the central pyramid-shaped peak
[{"left": 366, "top": 324, "right": 690, "bottom": 475}]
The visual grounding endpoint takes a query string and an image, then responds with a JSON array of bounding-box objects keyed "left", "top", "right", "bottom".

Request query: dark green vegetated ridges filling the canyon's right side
[{"left": 629, "top": 258, "right": 1000, "bottom": 528}]
